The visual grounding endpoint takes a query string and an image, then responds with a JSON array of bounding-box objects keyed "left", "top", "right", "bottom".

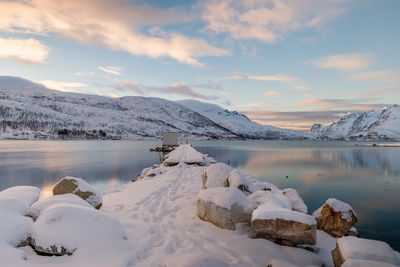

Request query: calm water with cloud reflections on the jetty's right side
[{"left": 196, "top": 141, "right": 400, "bottom": 251}]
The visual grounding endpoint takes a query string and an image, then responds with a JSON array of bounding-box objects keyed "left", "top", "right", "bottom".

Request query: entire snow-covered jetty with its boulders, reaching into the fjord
[{"left": 0, "top": 145, "right": 400, "bottom": 267}]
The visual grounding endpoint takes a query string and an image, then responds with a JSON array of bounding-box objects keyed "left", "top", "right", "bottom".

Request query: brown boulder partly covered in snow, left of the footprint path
[{"left": 53, "top": 176, "right": 103, "bottom": 209}]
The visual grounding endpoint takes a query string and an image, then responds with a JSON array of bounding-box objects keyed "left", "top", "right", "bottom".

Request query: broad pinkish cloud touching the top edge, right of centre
[{"left": 202, "top": 0, "right": 346, "bottom": 43}]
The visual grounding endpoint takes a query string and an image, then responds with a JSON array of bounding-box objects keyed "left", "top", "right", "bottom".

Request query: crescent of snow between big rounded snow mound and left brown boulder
[{"left": 31, "top": 194, "right": 92, "bottom": 218}]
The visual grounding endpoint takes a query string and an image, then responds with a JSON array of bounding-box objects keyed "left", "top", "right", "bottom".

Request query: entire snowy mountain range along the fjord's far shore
[{"left": 0, "top": 76, "right": 400, "bottom": 140}]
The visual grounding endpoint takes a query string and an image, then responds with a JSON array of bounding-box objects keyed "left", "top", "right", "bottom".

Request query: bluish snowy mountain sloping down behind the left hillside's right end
[{"left": 177, "top": 100, "right": 312, "bottom": 139}]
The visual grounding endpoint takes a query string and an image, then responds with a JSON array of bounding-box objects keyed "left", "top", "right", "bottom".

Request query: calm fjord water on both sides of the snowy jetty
[{"left": 0, "top": 141, "right": 400, "bottom": 251}]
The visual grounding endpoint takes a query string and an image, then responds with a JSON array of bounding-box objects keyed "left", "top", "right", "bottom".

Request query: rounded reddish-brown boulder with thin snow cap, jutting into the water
[{"left": 313, "top": 198, "right": 357, "bottom": 237}]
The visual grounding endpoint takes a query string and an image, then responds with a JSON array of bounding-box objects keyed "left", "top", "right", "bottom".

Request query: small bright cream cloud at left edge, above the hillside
[{"left": 0, "top": 36, "right": 50, "bottom": 64}]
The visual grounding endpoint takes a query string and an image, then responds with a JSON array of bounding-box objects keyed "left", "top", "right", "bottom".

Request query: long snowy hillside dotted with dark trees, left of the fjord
[{"left": 0, "top": 76, "right": 236, "bottom": 139}]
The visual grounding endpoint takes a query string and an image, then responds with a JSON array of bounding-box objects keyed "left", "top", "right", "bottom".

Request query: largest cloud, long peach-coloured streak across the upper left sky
[{"left": 0, "top": 0, "right": 230, "bottom": 66}]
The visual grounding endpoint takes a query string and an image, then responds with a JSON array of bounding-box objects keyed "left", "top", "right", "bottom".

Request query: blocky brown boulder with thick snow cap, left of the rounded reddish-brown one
[{"left": 251, "top": 205, "right": 317, "bottom": 246}]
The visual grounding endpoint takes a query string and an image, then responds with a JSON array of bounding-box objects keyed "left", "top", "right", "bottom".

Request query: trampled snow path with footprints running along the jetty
[{"left": 102, "top": 165, "right": 321, "bottom": 266}]
